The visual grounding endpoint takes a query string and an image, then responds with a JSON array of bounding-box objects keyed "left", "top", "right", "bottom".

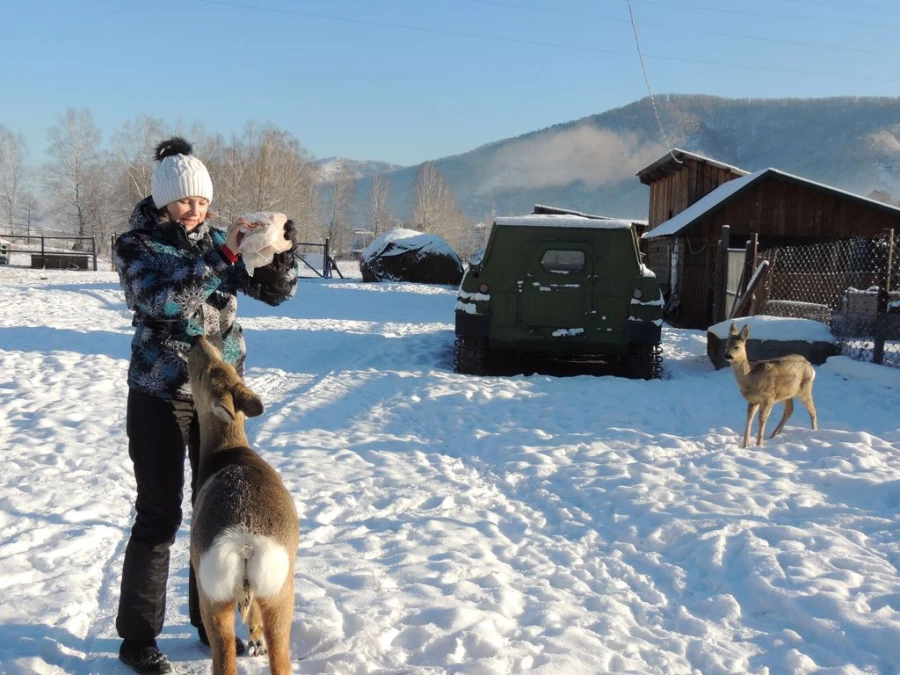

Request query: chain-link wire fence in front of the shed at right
[{"left": 753, "top": 231, "right": 900, "bottom": 368}]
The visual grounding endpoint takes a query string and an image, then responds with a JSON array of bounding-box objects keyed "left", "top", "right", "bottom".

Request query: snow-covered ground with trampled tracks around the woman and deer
[{"left": 0, "top": 268, "right": 900, "bottom": 675}]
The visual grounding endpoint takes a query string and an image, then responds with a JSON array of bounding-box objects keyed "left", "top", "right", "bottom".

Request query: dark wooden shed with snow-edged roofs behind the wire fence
[{"left": 637, "top": 150, "right": 900, "bottom": 328}]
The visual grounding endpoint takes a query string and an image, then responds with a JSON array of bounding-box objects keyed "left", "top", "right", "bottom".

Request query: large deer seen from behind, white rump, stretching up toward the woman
[{"left": 188, "top": 337, "right": 300, "bottom": 675}]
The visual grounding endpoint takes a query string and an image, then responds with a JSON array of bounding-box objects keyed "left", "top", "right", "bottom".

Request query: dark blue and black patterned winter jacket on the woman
[{"left": 113, "top": 197, "right": 297, "bottom": 401}]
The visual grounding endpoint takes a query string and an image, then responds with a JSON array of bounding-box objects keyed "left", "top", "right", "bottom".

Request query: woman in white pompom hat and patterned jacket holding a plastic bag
[{"left": 113, "top": 137, "right": 297, "bottom": 673}]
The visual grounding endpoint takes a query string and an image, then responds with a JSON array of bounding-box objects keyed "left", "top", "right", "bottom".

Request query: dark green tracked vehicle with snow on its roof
[{"left": 454, "top": 206, "right": 663, "bottom": 378}]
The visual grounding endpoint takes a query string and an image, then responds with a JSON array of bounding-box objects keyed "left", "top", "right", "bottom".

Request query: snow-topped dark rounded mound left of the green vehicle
[{"left": 359, "top": 228, "right": 463, "bottom": 286}]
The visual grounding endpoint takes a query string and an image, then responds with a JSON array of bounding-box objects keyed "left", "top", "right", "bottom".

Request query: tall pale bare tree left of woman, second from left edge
[{"left": 44, "top": 108, "right": 100, "bottom": 236}]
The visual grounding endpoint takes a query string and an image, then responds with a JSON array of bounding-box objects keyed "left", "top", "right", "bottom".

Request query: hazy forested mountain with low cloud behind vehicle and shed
[{"left": 348, "top": 95, "right": 900, "bottom": 219}]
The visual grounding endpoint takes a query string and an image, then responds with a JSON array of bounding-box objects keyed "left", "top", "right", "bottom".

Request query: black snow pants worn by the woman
[{"left": 116, "top": 390, "right": 202, "bottom": 640}]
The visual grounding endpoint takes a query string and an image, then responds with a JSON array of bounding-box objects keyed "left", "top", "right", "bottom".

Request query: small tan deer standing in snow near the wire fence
[{"left": 725, "top": 324, "right": 818, "bottom": 448}]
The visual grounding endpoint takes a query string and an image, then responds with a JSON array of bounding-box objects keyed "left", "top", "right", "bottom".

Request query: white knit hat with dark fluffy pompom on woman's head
[{"left": 150, "top": 136, "right": 212, "bottom": 209}]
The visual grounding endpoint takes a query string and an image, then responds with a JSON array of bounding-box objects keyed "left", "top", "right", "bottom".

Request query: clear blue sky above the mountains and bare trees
[{"left": 0, "top": 0, "right": 900, "bottom": 164}]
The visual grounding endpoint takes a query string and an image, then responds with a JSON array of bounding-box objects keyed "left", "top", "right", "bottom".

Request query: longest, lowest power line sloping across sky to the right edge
[{"left": 196, "top": 0, "right": 900, "bottom": 83}]
